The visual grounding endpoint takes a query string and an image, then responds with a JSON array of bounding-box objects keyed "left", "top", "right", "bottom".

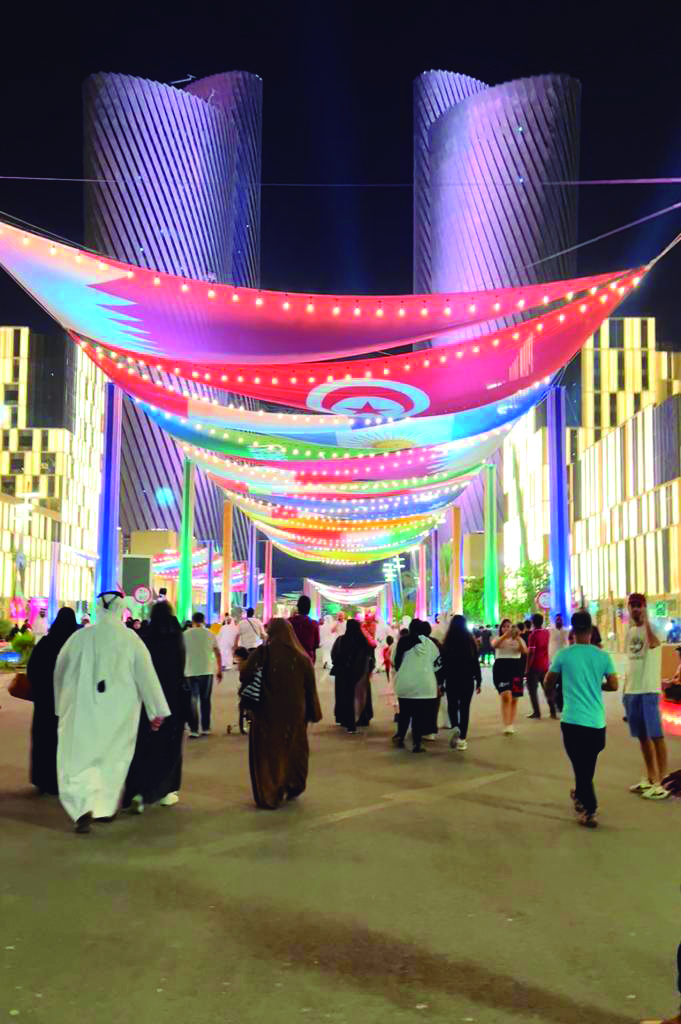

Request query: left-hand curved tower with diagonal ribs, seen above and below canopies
[{"left": 84, "top": 72, "right": 262, "bottom": 558}]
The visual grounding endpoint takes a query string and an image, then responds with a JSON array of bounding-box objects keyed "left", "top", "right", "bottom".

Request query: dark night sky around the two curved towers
[{"left": 0, "top": 0, "right": 681, "bottom": 585}]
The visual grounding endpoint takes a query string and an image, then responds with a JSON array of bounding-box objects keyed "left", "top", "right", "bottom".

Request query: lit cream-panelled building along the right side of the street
[{"left": 502, "top": 316, "right": 681, "bottom": 614}]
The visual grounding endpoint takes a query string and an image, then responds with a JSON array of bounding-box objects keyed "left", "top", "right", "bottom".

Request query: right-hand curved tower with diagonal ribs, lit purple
[{"left": 414, "top": 71, "right": 581, "bottom": 532}]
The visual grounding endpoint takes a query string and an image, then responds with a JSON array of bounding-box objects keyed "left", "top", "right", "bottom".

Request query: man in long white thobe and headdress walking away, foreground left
[{"left": 54, "top": 592, "right": 170, "bottom": 833}]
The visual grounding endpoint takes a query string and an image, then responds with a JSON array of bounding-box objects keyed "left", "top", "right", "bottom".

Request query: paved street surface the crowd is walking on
[{"left": 0, "top": 663, "right": 681, "bottom": 1024}]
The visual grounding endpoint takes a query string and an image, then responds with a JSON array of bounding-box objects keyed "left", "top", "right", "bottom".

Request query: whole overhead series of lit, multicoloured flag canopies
[{"left": 0, "top": 223, "right": 646, "bottom": 564}]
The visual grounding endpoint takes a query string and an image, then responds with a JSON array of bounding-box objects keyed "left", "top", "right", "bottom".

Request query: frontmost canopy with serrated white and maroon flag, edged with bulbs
[{"left": 0, "top": 222, "right": 639, "bottom": 369}]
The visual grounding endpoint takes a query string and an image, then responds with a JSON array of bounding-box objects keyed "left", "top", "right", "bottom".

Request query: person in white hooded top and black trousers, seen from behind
[{"left": 392, "top": 618, "right": 440, "bottom": 754}]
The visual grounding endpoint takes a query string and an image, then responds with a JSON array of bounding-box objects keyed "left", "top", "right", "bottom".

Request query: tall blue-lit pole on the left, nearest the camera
[{"left": 94, "top": 381, "right": 123, "bottom": 594}]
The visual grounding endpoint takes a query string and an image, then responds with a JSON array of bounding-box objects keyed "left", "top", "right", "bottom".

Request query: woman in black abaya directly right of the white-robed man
[{"left": 123, "top": 601, "right": 186, "bottom": 814}]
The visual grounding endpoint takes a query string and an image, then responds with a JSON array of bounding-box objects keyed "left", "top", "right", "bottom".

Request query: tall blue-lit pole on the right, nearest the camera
[{"left": 546, "top": 385, "right": 572, "bottom": 622}]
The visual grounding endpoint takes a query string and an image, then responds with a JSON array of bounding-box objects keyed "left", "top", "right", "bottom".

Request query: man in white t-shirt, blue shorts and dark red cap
[{"left": 624, "top": 594, "right": 670, "bottom": 800}]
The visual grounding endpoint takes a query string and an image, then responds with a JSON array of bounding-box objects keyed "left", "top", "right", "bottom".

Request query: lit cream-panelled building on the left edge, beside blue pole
[{"left": 0, "top": 327, "right": 103, "bottom": 614}]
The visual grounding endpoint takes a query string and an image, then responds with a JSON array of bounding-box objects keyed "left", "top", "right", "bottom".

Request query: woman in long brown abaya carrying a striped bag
[{"left": 240, "top": 618, "right": 322, "bottom": 810}]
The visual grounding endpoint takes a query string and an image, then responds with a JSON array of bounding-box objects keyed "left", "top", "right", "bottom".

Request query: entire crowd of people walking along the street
[{"left": 6, "top": 592, "right": 670, "bottom": 833}]
